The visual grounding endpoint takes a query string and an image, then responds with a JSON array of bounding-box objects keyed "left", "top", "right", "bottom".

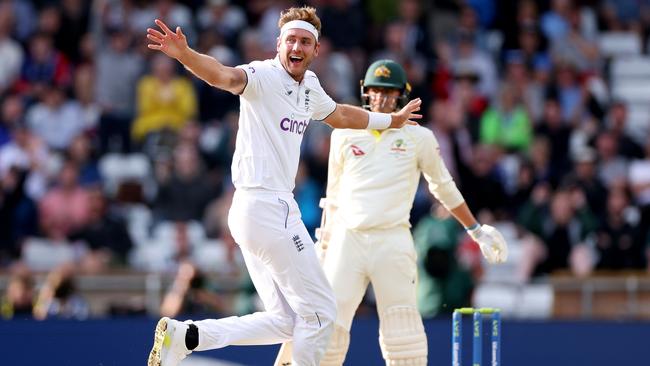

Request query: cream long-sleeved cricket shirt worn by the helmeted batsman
[{"left": 327, "top": 125, "right": 464, "bottom": 230}]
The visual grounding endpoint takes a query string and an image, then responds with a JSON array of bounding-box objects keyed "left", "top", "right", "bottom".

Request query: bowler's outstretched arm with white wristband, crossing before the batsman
[{"left": 325, "top": 98, "right": 422, "bottom": 130}]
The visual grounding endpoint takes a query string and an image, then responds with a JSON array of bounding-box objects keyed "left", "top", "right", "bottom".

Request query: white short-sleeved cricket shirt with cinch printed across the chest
[{"left": 231, "top": 57, "right": 336, "bottom": 192}]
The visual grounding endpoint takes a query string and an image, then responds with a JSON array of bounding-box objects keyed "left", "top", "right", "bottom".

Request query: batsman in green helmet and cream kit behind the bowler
[{"left": 276, "top": 60, "right": 508, "bottom": 366}]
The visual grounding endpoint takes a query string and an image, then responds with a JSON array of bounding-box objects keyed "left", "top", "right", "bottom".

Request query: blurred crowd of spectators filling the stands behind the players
[{"left": 0, "top": 0, "right": 650, "bottom": 317}]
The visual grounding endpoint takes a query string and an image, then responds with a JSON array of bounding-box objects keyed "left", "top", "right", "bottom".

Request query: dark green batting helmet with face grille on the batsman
[{"left": 361, "top": 60, "right": 411, "bottom": 110}]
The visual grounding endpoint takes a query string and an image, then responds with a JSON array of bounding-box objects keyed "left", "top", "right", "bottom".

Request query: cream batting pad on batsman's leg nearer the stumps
[{"left": 379, "top": 306, "right": 427, "bottom": 366}]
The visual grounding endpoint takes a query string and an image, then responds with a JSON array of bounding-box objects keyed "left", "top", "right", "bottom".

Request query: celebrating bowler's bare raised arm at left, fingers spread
[{"left": 147, "top": 19, "right": 246, "bottom": 94}]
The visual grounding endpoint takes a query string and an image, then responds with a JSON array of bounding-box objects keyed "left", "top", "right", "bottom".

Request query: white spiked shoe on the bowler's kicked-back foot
[{"left": 147, "top": 317, "right": 192, "bottom": 366}]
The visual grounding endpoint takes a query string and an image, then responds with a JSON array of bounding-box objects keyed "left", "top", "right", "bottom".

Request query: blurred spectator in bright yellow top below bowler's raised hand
[{"left": 132, "top": 55, "right": 197, "bottom": 143}]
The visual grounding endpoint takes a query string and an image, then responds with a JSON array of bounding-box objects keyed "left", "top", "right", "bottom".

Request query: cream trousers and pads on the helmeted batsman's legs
[{"left": 320, "top": 224, "right": 427, "bottom": 366}]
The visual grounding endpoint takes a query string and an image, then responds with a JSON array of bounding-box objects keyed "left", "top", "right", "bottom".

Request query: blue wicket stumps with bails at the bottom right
[{"left": 451, "top": 308, "right": 501, "bottom": 366}]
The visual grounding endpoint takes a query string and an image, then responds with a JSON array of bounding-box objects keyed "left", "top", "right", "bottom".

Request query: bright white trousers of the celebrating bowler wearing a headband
[{"left": 194, "top": 189, "right": 336, "bottom": 366}]
